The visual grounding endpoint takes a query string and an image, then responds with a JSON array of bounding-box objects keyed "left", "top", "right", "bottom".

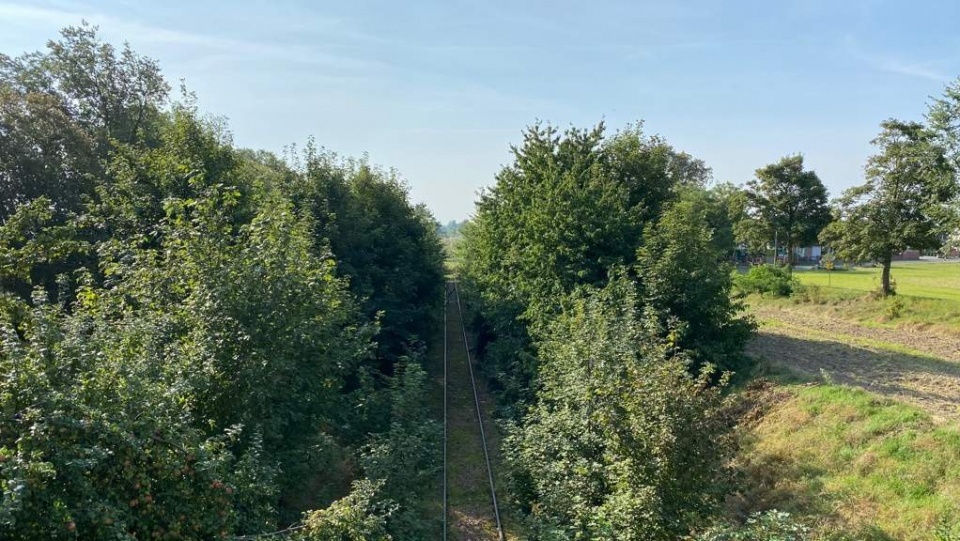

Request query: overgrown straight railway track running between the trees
[{"left": 443, "top": 282, "right": 505, "bottom": 541}]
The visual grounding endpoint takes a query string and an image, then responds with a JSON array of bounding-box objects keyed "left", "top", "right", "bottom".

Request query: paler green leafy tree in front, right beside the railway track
[{"left": 504, "top": 277, "right": 726, "bottom": 539}]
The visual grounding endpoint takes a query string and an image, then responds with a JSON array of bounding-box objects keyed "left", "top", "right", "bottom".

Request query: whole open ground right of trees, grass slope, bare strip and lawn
[{"left": 728, "top": 264, "right": 960, "bottom": 540}]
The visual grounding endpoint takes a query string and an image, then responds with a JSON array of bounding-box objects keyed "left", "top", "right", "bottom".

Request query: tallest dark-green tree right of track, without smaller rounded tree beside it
[{"left": 462, "top": 124, "right": 709, "bottom": 410}]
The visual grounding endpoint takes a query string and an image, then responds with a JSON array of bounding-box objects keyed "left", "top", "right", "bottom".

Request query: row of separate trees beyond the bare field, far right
[{"left": 714, "top": 95, "right": 960, "bottom": 296}]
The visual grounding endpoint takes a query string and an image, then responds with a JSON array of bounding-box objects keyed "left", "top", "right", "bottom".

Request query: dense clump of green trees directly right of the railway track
[{"left": 461, "top": 120, "right": 752, "bottom": 540}]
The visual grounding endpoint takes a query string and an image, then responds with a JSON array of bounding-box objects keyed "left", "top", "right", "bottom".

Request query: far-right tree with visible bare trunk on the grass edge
[{"left": 821, "top": 119, "right": 957, "bottom": 296}]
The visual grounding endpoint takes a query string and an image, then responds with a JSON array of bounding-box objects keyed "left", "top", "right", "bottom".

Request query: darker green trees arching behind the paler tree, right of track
[{"left": 461, "top": 120, "right": 750, "bottom": 412}]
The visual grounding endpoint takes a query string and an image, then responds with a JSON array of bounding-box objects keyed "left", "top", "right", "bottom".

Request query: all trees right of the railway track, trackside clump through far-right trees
[{"left": 459, "top": 83, "right": 960, "bottom": 540}]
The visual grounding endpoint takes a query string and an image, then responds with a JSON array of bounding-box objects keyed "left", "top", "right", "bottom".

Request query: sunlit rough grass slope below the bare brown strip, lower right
[{"left": 728, "top": 383, "right": 960, "bottom": 540}]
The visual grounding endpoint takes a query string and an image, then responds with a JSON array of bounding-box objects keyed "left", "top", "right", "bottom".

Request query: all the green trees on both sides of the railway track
[{"left": 0, "top": 21, "right": 960, "bottom": 540}]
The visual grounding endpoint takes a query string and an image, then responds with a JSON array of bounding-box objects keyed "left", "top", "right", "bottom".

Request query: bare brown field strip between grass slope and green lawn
[{"left": 747, "top": 307, "right": 960, "bottom": 421}]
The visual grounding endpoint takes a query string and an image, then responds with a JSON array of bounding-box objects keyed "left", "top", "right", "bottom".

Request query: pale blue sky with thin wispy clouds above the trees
[{"left": 0, "top": 0, "right": 960, "bottom": 221}]
